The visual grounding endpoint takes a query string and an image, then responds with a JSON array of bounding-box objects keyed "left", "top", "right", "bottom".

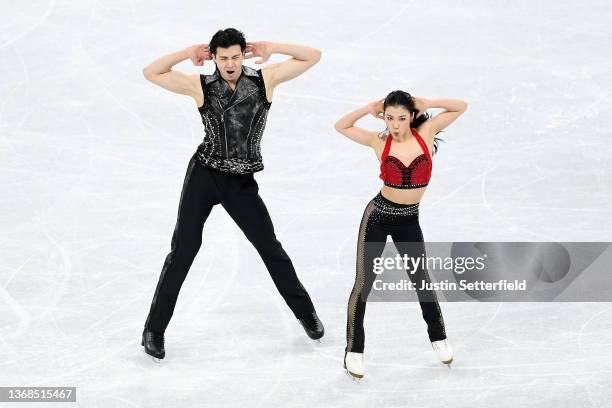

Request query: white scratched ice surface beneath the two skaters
[{"left": 0, "top": 0, "right": 612, "bottom": 408}]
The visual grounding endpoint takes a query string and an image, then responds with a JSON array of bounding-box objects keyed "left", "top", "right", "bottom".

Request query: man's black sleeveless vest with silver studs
[{"left": 196, "top": 65, "right": 271, "bottom": 174}]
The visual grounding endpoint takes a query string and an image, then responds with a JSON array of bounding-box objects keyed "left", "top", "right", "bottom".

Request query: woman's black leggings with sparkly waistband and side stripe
[{"left": 345, "top": 193, "right": 446, "bottom": 353}]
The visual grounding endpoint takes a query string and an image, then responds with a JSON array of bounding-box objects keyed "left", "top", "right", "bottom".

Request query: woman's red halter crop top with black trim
[{"left": 380, "top": 128, "right": 432, "bottom": 188}]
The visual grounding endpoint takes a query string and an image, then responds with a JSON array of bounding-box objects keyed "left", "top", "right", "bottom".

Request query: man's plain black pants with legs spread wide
[{"left": 145, "top": 155, "right": 314, "bottom": 332}]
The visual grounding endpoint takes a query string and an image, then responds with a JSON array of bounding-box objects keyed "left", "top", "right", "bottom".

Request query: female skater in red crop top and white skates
[{"left": 335, "top": 91, "right": 467, "bottom": 378}]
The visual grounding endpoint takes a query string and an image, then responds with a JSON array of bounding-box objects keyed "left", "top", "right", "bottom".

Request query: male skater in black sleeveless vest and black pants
[{"left": 142, "top": 28, "right": 324, "bottom": 359}]
